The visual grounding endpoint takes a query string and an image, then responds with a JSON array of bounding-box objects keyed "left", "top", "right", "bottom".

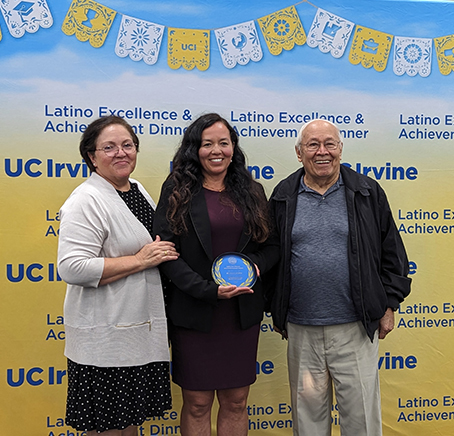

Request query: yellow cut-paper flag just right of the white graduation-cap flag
[{"left": 61, "top": 0, "right": 117, "bottom": 48}]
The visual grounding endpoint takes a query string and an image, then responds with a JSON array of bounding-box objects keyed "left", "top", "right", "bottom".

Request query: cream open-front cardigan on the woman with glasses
[{"left": 58, "top": 173, "right": 169, "bottom": 367}]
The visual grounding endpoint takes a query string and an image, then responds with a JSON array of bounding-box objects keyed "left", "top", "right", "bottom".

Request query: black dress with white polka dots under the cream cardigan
[{"left": 65, "top": 183, "right": 172, "bottom": 433}]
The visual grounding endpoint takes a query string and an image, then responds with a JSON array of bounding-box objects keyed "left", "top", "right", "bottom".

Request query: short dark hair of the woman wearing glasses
[{"left": 79, "top": 115, "right": 139, "bottom": 172}]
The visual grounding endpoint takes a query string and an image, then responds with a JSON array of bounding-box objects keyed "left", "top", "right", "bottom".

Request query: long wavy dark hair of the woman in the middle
[{"left": 167, "top": 113, "right": 270, "bottom": 242}]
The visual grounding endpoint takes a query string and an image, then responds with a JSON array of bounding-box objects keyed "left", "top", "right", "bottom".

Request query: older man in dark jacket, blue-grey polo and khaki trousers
[{"left": 270, "top": 120, "right": 411, "bottom": 436}]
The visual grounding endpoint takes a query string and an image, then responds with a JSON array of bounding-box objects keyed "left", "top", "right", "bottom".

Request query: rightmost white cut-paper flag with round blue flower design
[{"left": 393, "top": 36, "right": 432, "bottom": 77}]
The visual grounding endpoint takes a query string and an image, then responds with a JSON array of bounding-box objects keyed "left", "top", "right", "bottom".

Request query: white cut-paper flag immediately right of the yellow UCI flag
[{"left": 214, "top": 21, "right": 263, "bottom": 68}]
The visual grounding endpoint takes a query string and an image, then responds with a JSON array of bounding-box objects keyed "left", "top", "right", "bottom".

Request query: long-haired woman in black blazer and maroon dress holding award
[{"left": 153, "top": 114, "right": 278, "bottom": 436}]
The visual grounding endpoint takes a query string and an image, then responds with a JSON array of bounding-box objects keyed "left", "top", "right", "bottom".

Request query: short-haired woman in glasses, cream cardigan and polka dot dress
[{"left": 58, "top": 116, "right": 178, "bottom": 436}]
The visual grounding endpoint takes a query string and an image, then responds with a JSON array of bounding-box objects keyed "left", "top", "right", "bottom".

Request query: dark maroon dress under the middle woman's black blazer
[{"left": 170, "top": 189, "right": 260, "bottom": 391}]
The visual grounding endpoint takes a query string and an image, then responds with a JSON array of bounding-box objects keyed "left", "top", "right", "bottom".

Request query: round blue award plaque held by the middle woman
[{"left": 211, "top": 253, "right": 257, "bottom": 288}]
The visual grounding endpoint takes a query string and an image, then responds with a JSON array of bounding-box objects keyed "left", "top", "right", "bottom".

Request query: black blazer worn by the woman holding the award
[{"left": 153, "top": 180, "right": 279, "bottom": 332}]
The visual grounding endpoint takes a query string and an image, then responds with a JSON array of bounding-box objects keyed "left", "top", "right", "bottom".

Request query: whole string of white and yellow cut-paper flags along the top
[{"left": 0, "top": 0, "right": 454, "bottom": 77}]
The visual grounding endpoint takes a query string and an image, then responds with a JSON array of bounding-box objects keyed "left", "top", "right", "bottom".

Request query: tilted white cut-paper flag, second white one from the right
[{"left": 307, "top": 8, "right": 355, "bottom": 58}]
